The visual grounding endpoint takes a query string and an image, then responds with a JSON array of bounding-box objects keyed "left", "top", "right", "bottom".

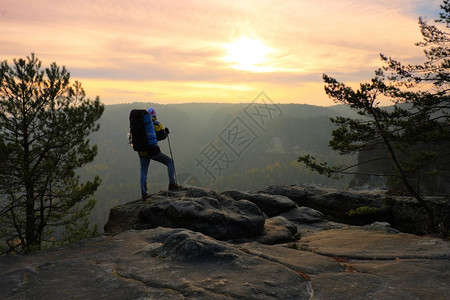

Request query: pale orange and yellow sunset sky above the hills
[{"left": 0, "top": 0, "right": 442, "bottom": 106}]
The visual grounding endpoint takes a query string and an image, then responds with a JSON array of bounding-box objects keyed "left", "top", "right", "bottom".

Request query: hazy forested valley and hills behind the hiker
[{"left": 79, "top": 102, "right": 356, "bottom": 230}]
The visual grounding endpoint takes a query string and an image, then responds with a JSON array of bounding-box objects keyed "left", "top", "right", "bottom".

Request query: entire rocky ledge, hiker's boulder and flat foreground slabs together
[{"left": 0, "top": 186, "right": 450, "bottom": 299}]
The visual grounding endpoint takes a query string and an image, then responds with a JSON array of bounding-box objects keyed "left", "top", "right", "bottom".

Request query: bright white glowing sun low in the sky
[{"left": 224, "top": 37, "right": 272, "bottom": 72}]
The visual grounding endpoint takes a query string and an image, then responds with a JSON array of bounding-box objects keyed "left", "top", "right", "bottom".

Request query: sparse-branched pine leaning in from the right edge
[{"left": 298, "top": 0, "right": 450, "bottom": 231}]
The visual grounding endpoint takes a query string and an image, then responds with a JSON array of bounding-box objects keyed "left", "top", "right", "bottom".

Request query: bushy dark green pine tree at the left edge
[{"left": 0, "top": 54, "right": 104, "bottom": 253}]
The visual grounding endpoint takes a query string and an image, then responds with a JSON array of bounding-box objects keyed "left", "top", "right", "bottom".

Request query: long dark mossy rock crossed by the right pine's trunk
[{"left": 261, "top": 184, "right": 450, "bottom": 234}]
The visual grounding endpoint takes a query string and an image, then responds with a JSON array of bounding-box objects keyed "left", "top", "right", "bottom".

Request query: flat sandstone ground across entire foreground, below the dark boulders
[{"left": 0, "top": 227, "right": 450, "bottom": 299}]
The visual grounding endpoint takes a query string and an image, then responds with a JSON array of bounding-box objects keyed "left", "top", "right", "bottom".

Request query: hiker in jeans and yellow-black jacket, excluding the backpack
[{"left": 130, "top": 108, "right": 181, "bottom": 200}]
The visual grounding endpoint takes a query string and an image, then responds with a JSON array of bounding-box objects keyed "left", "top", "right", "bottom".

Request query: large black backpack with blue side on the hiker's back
[{"left": 130, "top": 109, "right": 158, "bottom": 152}]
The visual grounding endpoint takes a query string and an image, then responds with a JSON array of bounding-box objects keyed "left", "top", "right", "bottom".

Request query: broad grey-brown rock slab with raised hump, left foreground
[{"left": 0, "top": 228, "right": 309, "bottom": 299}]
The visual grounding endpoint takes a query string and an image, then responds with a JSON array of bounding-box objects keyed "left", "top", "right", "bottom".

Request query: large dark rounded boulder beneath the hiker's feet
[{"left": 105, "top": 187, "right": 266, "bottom": 240}]
